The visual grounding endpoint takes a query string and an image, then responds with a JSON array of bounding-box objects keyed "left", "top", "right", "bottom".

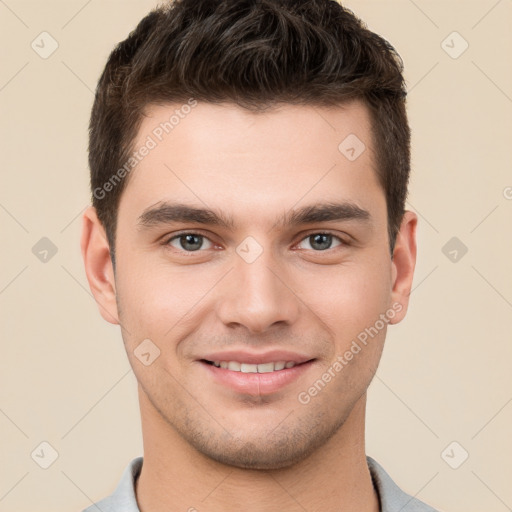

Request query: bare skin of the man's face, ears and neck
[{"left": 82, "top": 101, "right": 417, "bottom": 512}]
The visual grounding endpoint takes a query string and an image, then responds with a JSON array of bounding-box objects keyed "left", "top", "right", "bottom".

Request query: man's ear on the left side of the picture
[{"left": 80, "top": 206, "right": 119, "bottom": 324}]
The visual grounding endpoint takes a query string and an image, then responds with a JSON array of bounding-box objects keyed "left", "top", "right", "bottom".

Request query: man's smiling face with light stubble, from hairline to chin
[{"left": 90, "top": 102, "right": 414, "bottom": 469}]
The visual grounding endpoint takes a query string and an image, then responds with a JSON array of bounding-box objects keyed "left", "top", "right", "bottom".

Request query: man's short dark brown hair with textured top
[{"left": 89, "top": 0, "right": 410, "bottom": 262}]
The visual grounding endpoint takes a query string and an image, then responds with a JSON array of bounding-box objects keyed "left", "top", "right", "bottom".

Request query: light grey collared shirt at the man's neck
[{"left": 82, "top": 457, "right": 438, "bottom": 512}]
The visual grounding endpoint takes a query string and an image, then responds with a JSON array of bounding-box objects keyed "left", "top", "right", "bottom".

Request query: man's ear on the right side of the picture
[{"left": 390, "top": 211, "right": 418, "bottom": 324}]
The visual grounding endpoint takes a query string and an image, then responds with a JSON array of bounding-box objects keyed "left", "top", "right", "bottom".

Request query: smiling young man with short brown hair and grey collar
[{"left": 81, "top": 0, "right": 440, "bottom": 512}]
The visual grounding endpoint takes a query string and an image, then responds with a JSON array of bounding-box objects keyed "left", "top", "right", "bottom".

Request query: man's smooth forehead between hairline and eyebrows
[{"left": 120, "top": 102, "right": 384, "bottom": 226}]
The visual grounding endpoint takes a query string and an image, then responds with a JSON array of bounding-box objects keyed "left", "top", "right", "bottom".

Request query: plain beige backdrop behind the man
[{"left": 0, "top": 0, "right": 512, "bottom": 512}]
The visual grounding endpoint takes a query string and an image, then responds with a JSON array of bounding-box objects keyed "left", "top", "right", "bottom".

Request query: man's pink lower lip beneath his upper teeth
[{"left": 201, "top": 361, "right": 313, "bottom": 396}]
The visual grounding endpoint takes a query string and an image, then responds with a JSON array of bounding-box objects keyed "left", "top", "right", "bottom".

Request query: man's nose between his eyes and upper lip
[{"left": 216, "top": 251, "right": 301, "bottom": 333}]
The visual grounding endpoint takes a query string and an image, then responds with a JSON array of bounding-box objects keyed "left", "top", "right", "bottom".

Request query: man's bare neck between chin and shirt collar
[{"left": 135, "top": 389, "right": 380, "bottom": 512}]
